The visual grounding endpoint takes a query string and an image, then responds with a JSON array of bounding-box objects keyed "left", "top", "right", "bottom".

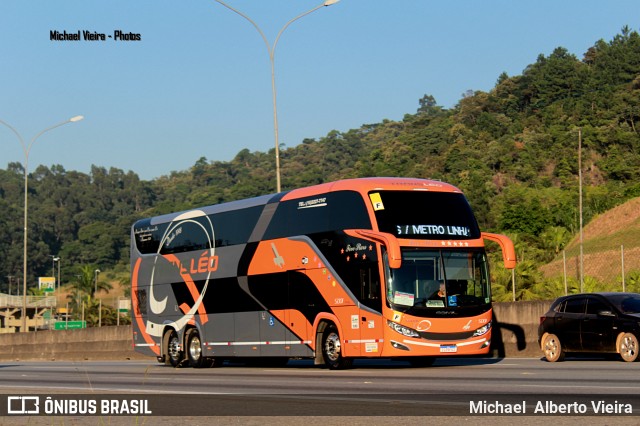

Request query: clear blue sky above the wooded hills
[{"left": 0, "top": 0, "right": 640, "bottom": 179}]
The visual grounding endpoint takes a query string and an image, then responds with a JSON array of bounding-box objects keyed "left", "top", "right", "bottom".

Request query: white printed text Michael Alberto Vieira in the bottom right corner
[{"left": 469, "top": 400, "right": 633, "bottom": 414}]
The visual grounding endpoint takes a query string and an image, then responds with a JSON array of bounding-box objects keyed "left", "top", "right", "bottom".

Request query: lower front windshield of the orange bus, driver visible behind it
[{"left": 386, "top": 249, "right": 491, "bottom": 316}]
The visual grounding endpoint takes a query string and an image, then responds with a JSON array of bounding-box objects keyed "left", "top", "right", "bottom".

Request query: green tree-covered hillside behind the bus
[{"left": 0, "top": 27, "right": 640, "bottom": 300}]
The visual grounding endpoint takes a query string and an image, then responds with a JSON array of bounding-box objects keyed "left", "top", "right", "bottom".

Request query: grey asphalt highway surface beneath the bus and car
[{"left": 0, "top": 358, "right": 640, "bottom": 426}]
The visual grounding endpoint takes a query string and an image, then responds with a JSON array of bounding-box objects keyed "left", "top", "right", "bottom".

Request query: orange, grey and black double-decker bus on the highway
[{"left": 131, "top": 178, "right": 515, "bottom": 369}]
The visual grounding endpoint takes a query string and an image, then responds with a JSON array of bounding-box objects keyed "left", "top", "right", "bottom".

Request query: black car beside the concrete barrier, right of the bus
[{"left": 538, "top": 293, "right": 640, "bottom": 362}]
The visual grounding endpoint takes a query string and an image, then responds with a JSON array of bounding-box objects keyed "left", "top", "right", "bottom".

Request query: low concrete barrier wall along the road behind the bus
[{"left": 0, "top": 301, "right": 551, "bottom": 361}]
